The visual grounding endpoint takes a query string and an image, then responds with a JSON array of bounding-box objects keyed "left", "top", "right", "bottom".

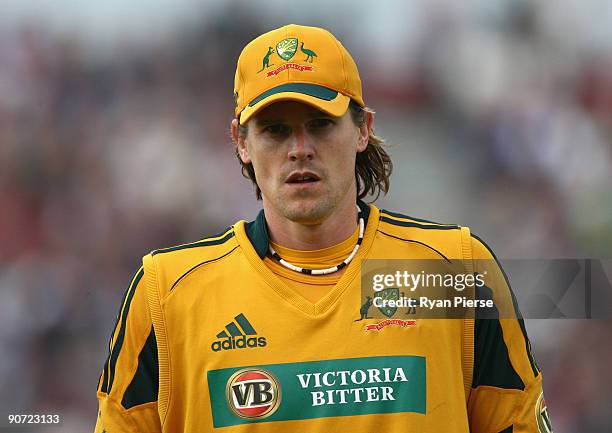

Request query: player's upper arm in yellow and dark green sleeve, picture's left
[{"left": 96, "top": 268, "right": 161, "bottom": 433}]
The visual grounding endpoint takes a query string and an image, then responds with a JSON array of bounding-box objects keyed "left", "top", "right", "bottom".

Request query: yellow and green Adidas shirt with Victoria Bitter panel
[{"left": 95, "top": 202, "right": 551, "bottom": 433}]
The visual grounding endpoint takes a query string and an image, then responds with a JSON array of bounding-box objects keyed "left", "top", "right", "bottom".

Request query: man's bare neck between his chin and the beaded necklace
[{"left": 264, "top": 199, "right": 357, "bottom": 250}]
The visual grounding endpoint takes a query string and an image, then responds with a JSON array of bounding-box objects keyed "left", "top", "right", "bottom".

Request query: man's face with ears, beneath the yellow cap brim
[{"left": 232, "top": 101, "right": 371, "bottom": 224}]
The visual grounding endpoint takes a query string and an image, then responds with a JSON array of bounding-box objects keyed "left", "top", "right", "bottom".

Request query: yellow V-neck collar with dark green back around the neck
[{"left": 234, "top": 201, "right": 379, "bottom": 316}]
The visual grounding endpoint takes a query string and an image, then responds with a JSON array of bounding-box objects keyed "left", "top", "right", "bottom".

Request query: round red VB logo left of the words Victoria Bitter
[{"left": 226, "top": 369, "right": 281, "bottom": 419}]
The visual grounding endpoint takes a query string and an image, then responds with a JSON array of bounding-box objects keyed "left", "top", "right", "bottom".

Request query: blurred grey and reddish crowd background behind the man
[{"left": 0, "top": 0, "right": 612, "bottom": 433}]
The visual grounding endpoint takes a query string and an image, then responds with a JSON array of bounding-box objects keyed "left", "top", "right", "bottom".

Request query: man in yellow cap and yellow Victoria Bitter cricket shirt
[{"left": 96, "top": 25, "right": 551, "bottom": 433}]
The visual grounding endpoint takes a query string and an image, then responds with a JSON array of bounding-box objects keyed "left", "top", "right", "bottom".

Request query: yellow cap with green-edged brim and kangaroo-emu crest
[{"left": 234, "top": 24, "right": 365, "bottom": 123}]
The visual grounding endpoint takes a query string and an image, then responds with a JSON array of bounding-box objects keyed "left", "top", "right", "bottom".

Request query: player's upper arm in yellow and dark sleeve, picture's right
[{"left": 468, "top": 237, "right": 550, "bottom": 433}]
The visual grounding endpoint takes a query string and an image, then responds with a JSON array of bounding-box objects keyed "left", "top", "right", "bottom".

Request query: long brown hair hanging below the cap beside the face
[{"left": 235, "top": 100, "right": 393, "bottom": 200}]
